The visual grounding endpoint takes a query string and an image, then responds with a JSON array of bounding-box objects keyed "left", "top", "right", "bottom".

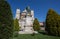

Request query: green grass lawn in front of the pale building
[{"left": 13, "top": 34, "right": 60, "bottom": 39}]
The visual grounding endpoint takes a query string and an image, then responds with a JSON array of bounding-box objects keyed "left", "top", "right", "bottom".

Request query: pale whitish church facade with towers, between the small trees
[{"left": 16, "top": 7, "right": 34, "bottom": 34}]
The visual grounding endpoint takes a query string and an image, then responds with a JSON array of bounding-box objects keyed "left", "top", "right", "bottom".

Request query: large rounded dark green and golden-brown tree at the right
[{"left": 45, "top": 9, "right": 59, "bottom": 36}]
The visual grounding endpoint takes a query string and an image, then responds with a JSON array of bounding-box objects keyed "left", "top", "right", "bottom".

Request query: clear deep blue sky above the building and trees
[{"left": 7, "top": 0, "right": 60, "bottom": 22}]
